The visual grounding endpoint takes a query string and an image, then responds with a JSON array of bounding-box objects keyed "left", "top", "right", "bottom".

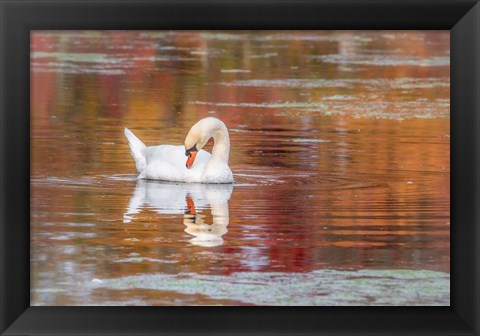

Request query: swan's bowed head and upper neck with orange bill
[{"left": 185, "top": 117, "right": 226, "bottom": 169}]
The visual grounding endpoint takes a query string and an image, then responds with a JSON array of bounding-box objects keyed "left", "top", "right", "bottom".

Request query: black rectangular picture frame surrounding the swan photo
[{"left": 0, "top": 0, "right": 480, "bottom": 335}]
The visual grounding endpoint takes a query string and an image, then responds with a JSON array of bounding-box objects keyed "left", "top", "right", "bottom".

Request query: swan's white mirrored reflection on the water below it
[{"left": 123, "top": 180, "right": 233, "bottom": 247}]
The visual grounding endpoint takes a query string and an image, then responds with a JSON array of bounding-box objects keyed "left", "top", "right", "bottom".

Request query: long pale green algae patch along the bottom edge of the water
[{"left": 90, "top": 270, "right": 450, "bottom": 306}]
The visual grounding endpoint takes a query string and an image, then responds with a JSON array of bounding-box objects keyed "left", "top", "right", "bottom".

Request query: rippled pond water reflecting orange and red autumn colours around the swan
[{"left": 31, "top": 31, "right": 450, "bottom": 305}]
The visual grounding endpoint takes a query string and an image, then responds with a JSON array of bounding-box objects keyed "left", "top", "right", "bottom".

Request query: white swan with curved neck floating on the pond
[{"left": 125, "top": 117, "right": 233, "bottom": 183}]
